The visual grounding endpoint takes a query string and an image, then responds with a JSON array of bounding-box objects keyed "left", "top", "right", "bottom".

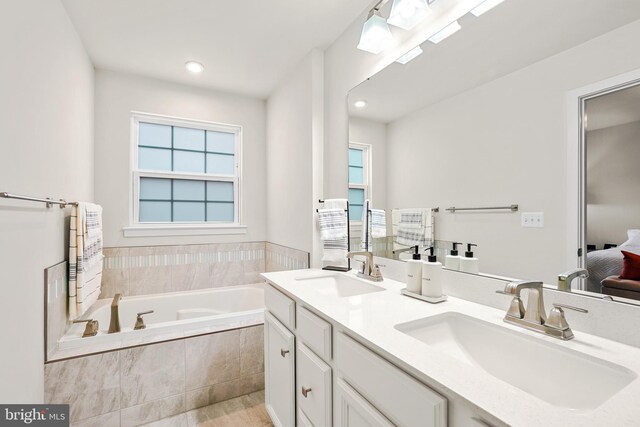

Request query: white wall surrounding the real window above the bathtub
[{"left": 95, "top": 70, "right": 266, "bottom": 246}]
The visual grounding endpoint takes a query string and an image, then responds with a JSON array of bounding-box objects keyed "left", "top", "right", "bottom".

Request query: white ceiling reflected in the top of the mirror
[{"left": 349, "top": 0, "right": 640, "bottom": 123}]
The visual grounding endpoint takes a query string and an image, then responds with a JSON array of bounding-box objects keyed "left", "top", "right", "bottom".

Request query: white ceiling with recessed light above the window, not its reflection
[{"left": 62, "top": 0, "right": 371, "bottom": 98}]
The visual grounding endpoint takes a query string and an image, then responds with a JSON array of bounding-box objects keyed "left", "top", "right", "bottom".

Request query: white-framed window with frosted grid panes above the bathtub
[{"left": 125, "top": 114, "right": 241, "bottom": 235}]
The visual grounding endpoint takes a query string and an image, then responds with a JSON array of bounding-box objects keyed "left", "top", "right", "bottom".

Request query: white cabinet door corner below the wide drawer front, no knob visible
[{"left": 335, "top": 379, "right": 393, "bottom": 427}]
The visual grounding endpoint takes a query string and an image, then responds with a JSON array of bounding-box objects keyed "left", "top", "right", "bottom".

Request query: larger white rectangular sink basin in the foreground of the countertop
[{"left": 395, "top": 313, "right": 636, "bottom": 411}]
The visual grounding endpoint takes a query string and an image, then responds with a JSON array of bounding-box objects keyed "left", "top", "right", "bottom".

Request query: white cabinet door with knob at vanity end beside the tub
[{"left": 264, "top": 312, "right": 296, "bottom": 427}]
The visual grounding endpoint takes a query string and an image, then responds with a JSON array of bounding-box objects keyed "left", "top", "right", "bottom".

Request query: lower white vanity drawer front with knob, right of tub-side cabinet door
[{"left": 296, "top": 343, "right": 332, "bottom": 427}]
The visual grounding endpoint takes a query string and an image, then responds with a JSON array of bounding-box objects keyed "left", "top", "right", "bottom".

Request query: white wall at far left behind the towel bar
[{"left": 0, "top": 0, "right": 94, "bottom": 403}]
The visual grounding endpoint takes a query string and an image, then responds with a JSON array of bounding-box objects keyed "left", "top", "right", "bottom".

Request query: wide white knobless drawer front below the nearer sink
[{"left": 335, "top": 334, "right": 447, "bottom": 427}]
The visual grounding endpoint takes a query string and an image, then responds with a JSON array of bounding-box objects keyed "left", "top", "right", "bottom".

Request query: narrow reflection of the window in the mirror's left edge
[{"left": 349, "top": 142, "right": 371, "bottom": 222}]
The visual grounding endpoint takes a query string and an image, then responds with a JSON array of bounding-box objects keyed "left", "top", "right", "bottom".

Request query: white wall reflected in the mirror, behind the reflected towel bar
[{"left": 388, "top": 22, "right": 640, "bottom": 283}]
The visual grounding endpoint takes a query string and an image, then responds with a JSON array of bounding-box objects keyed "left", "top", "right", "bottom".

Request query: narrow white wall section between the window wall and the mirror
[{"left": 266, "top": 50, "right": 323, "bottom": 265}]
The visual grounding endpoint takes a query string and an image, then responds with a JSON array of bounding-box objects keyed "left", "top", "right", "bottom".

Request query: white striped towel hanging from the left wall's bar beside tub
[{"left": 69, "top": 203, "right": 103, "bottom": 320}]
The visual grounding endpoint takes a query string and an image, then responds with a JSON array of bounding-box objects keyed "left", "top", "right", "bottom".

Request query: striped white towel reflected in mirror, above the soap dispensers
[{"left": 391, "top": 208, "right": 433, "bottom": 250}]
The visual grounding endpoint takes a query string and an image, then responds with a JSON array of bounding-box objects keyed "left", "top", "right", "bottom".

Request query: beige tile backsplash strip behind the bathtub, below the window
[{"left": 101, "top": 242, "right": 309, "bottom": 298}]
